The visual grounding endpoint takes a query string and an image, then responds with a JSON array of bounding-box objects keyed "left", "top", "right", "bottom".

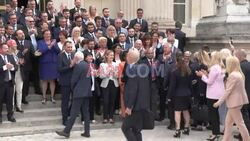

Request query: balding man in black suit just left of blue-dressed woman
[{"left": 16, "top": 30, "right": 35, "bottom": 104}]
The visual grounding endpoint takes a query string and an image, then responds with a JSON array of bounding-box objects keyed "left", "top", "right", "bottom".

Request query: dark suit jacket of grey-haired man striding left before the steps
[{"left": 71, "top": 61, "right": 92, "bottom": 98}]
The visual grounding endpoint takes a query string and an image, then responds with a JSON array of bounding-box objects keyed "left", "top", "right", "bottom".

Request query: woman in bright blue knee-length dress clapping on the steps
[{"left": 37, "top": 30, "right": 60, "bottom": 104}]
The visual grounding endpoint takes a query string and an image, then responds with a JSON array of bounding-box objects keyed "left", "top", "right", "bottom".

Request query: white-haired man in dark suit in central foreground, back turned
[{"left": 121, "top": 48, "right": 150, "bottom": 141}]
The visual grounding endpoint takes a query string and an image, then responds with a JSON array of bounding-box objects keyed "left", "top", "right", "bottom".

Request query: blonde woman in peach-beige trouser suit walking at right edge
[{"left": 213, "top": 56, "right": 250, "bottom": 141}]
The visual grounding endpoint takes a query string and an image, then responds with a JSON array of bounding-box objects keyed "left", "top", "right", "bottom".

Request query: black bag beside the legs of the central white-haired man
[{"left": 142, "top": 110, "right": 155, "bottom": 130}]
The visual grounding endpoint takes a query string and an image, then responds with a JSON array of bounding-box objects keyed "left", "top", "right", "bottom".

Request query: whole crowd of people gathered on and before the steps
[{"left": 0, "top": 0, "right": 250, "bottom": 141}]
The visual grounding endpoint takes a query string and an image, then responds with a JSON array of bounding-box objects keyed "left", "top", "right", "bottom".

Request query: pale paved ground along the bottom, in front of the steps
[{"left": 0, "top": 126, "right": 238, "bottom": 141}]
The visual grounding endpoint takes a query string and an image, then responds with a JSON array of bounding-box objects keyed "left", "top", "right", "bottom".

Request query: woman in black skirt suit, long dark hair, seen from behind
[{"left": 168, "top": 53, "right": 192, "bottom": 138}]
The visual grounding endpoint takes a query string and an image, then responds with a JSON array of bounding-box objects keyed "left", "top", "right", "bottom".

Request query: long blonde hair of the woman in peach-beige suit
[{"left": 226, "top": 56, "right": 245, "bottom": 80}]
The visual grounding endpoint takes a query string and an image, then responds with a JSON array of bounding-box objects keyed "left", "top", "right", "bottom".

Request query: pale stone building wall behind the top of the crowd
[{"left": 54, "top": 0, "right": 216, "bottom": 37}]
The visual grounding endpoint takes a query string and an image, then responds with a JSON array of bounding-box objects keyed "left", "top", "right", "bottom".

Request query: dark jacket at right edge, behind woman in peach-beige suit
[{"left": 240, "top": 60, "right": 250, "bottom": 100}]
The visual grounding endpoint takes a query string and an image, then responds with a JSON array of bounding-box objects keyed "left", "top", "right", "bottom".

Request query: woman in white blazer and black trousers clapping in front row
[{"left": 99, "top": 50, "right": 119, "bottom": 124}]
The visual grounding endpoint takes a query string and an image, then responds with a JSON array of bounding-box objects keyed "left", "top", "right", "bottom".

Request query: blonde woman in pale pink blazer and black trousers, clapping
[{"left": 196, "top": 52, "right": 225, "bottom": 141}]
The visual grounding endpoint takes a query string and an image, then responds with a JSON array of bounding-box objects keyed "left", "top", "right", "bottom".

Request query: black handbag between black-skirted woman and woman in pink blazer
[{"left": 191, "top": 100, "right": 209, "bottom": 122}]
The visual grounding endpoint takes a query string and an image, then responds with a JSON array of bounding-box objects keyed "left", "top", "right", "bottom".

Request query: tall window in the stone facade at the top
[{"left": 174, "top": 0, "right": 189, "bottom": 24}]
